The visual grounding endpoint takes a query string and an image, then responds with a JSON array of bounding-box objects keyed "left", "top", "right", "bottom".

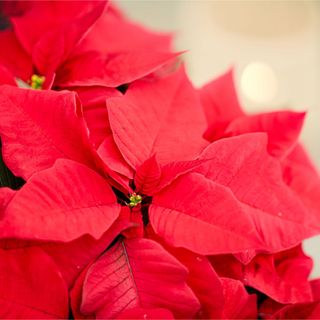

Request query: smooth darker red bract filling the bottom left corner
[{"left": 0, "top": 248, "right": 69, "bottom": 319}]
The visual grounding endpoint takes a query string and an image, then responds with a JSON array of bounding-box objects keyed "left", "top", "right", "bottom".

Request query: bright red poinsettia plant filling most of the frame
[{"left": 0, "top": 0, "right": 320, "bottom": 319}]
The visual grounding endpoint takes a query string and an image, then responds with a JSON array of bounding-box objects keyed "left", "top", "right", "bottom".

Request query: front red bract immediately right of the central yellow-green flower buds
[{"left": 149, "top": 173, "right": 263, "bottom": 255}]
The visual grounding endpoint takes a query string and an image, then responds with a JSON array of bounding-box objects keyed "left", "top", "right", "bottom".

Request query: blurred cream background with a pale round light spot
[{"left": 117, "top": 0, "right": 320, "bottom": 277}]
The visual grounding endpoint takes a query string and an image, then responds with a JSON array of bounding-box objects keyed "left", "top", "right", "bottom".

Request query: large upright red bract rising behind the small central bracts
[{"left": 107, "top": 69, "right": 206, "bottom": 169}]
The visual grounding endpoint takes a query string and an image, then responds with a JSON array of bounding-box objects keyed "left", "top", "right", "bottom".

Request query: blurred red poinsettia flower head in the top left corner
[{"left": 0, "top": 1, "right": 177, "bottom": 89}]
